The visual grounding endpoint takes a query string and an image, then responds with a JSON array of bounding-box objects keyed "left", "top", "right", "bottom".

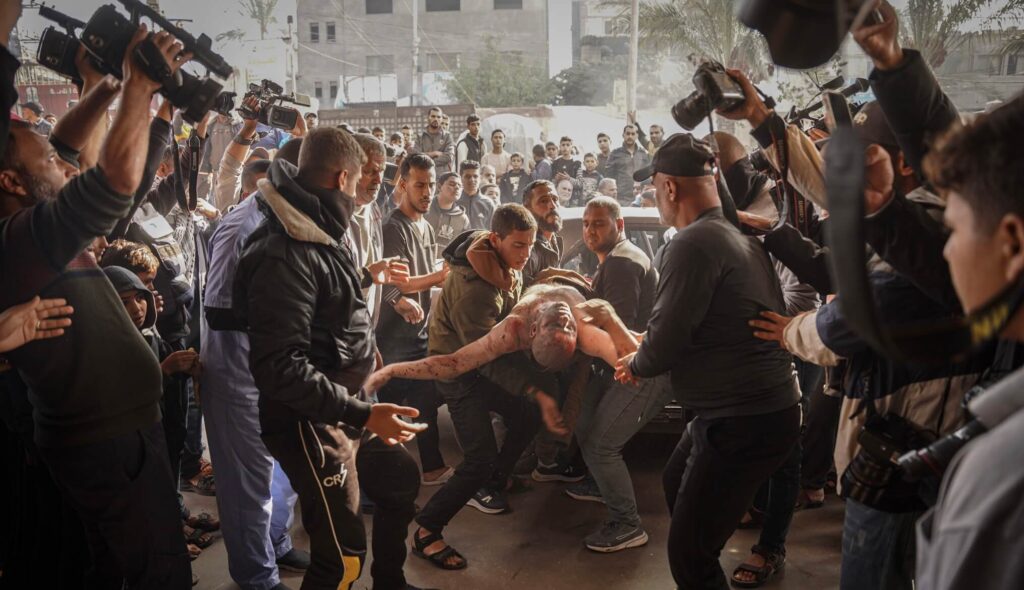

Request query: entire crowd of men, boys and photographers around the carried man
[{"left": 0, "top": 0, "right": 1024, "bottom": 590}]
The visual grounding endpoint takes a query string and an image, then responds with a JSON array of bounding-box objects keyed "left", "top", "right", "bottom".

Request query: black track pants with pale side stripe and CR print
[{"left": 262, "top": 421, "right": 420, "bottom": 590}]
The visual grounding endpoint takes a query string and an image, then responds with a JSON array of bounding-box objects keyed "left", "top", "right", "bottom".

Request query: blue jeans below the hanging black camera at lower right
[{"left": 840, "top": 499, "right": 923, "bottom": 590}]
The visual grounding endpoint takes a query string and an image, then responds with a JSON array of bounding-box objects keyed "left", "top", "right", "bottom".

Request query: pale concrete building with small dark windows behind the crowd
[{"left": 296, "top": 0, "right": 571, "bottom": 104}]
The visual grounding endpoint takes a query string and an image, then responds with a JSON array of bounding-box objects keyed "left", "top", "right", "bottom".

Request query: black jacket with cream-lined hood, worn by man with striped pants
[{"left": 233, "top": 161, "right": 375, "bottom": 433}]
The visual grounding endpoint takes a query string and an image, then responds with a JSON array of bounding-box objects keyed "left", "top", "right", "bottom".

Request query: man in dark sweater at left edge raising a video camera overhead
[{"left": 0, "top": 26, "right": 191, "bottom": 588}]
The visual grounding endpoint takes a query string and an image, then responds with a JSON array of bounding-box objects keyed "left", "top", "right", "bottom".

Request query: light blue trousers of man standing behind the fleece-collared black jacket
[{"left": 202, "top": 387, "right": 298, "bottom": 590}]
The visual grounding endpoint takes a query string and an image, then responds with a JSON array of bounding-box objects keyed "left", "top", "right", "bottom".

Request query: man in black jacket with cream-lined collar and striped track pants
[{"left": 233, "top": 127, "right": 422, "bottom": 589}]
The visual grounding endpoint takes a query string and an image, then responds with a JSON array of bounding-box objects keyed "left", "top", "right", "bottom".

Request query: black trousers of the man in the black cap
[{"left": 663, "top": 406, "right": 800, "bottom": 590}]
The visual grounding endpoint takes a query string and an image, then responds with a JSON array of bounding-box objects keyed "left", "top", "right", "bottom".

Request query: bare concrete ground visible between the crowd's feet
[{"left": 185, "top": 409, "right": 843, "bottom": 590}]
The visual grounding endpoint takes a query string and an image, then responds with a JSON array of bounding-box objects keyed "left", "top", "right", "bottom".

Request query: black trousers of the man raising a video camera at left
[{"left": 39, "top": 422, "right": 191, "bottom": 589}]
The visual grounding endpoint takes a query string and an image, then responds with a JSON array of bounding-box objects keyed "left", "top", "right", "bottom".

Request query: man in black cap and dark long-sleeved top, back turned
[{"left": 615, "top": 133, "right": 800, "bottom": 588}]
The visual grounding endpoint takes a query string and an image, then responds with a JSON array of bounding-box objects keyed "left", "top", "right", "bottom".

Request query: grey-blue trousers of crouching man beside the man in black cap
[{"left": 575, "top": 371, "right": 672, "bottom": 526}]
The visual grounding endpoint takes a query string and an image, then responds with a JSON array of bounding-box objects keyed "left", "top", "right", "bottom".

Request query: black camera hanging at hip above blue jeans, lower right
[{"left": 842, "top": 413, "right": 935, "bottom": 512}]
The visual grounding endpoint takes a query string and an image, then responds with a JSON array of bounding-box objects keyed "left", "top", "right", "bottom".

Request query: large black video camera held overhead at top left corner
[{"left": 36, "top": 0, "right": 234, "bottom": 123}]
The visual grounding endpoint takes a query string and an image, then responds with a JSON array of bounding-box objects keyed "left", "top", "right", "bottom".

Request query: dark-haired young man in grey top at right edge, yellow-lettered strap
[{"left": 918, "top": 92, "right": 1024, "bottom": 590}]
